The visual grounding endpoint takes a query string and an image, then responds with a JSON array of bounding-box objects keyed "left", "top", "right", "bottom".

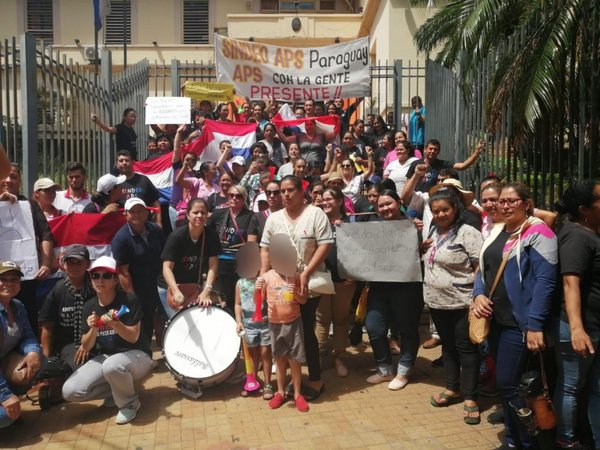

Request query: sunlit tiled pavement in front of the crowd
[{"left": 0, "top": 328, "right": 502, "bottom": 450}]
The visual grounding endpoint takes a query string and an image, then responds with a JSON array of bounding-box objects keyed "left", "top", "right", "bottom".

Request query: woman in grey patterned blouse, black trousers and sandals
[{"left": 422, "top": 184, "right": 483, "bottom": 425}]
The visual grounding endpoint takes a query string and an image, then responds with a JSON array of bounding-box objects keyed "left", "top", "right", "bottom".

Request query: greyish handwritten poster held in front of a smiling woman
[{"left": 336, "top": 220, "right": 423, "bottom": 282}]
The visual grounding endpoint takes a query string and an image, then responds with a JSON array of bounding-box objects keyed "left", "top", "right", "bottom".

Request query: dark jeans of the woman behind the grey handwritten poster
[{"left": 365, "top": 283, "right": 423, "bottom": 376}]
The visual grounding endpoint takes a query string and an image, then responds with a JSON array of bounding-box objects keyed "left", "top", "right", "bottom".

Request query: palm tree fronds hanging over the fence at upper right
[{"left": 413, "top": 0, "right": 600, "bottom": 175}]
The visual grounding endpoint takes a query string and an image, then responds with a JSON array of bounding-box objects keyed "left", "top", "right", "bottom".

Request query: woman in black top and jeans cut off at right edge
[{"left": 554, "top": 180, "right": 600, "bottom": 448}]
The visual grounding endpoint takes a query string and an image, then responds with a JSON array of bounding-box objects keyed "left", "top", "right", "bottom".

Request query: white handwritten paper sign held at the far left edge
[{"left": 0, "top": 201, "right": 39, "bottom": 280}]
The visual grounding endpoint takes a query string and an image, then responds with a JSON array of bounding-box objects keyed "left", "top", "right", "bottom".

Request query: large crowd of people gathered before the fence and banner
[{"left": 0, "top": 97, "right": 600, "bottom": 449}]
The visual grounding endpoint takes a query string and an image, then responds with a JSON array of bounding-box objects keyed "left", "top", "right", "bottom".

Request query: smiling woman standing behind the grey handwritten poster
[{"left": 365, "top": 189, "right": 423, "bottom": 391}]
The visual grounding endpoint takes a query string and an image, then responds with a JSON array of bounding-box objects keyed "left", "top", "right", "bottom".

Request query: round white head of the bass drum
[{"left": 163, "top": 306, "right": 240, "bottom": 380}]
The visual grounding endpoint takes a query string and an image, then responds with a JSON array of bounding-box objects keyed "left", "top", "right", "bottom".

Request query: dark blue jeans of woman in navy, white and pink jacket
[{"left": 488, "top": 326, "right": 533, "bottom": 449}]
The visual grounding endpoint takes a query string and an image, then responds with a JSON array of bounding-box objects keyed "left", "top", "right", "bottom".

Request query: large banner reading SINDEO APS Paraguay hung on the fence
[{"left": 215, "top": 34, "right": 371, "bottom": 101}]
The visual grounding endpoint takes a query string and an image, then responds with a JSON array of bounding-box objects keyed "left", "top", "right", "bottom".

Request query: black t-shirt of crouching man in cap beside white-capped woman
[{"left": 39, "top": 280, "right": 96, "bottom": 354}]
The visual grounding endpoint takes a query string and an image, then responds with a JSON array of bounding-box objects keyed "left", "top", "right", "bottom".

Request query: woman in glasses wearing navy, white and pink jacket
[{"left": 473, "top": 183, "right": 558, "bottom": 448}]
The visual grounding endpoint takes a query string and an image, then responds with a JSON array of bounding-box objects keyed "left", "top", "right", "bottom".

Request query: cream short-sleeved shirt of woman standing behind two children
[{"left": 260, "top": 205, "right": 333, "bottom": 272}]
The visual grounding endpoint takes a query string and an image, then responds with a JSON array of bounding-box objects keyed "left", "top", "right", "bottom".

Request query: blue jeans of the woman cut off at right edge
[{"left": 554, "top": 320, "right": 600, "bottom": 448}]
